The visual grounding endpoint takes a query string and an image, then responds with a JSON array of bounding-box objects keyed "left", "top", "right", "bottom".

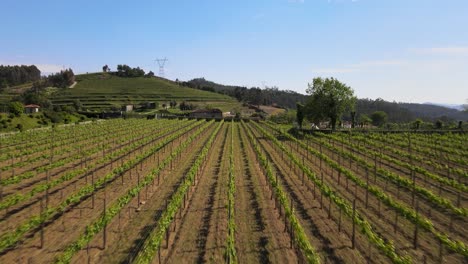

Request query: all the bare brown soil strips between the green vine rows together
[{"left": 0, "top": 121, "right": 468, "bottom": 264}]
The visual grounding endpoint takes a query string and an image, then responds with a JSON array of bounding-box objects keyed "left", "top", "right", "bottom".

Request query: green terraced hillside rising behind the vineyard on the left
[{"left": 51, "top": 73, "right": 240, "bottom": 111}]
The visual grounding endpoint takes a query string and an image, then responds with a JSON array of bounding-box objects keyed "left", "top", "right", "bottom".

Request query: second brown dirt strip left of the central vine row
[{"left": 72, "top": 122, "right": 218, "bottom": 263}]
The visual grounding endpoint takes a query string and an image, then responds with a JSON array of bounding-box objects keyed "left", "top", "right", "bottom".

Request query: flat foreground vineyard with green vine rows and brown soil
[{"left": 0, "top": 120, "right": 468, "bottom": 263}]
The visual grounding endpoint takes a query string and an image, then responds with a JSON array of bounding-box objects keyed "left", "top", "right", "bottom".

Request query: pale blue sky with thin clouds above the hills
[{"left": 0, "top": 0, "right": 468, "bottom": 104}]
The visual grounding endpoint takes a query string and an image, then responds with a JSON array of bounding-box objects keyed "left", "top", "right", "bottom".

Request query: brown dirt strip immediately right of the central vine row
[{"left": 234, "top": 122, "right": 299, "bottom": 263}]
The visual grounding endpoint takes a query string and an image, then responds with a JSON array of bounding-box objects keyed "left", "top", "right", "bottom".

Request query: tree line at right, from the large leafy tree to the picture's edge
[{"left": 296, "top": 78, "right": 468, "bottom": 130}]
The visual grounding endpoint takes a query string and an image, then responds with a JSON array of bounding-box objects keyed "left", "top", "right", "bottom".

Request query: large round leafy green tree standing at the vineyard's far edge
[{"left": 306, "top": 77, "right": 356, "bottom": 130}]
